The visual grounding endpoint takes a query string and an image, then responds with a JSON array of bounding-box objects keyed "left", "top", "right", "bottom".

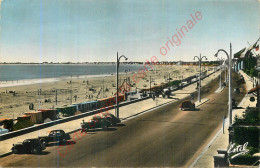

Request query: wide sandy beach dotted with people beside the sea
[{"left": 0, "top": 65, "right": 207, "bottom": 119}]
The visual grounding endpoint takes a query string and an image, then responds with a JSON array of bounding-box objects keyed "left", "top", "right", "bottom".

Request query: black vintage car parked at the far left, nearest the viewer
[{"left": 11, "top": 138, "right": 45, "bottom": 154}]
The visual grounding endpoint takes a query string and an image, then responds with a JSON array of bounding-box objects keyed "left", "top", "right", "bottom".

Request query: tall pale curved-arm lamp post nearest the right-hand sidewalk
[{"left": 215, "top": 43, "right": 232, "bottom": 125}]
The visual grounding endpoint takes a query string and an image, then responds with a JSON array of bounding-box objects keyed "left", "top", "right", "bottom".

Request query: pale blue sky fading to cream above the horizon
[{"left": 0, "top": 0, "right": 260, "bottom": 62}]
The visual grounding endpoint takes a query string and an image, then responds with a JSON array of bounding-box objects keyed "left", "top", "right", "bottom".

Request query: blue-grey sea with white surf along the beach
[{"left": 0, "top": 64, "right": 143, "bottom": 87}]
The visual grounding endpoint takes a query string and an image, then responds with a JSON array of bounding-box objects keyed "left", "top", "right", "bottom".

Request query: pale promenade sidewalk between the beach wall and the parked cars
[{"left": 0, "top": 69, "right": 219, "bottom": 157}]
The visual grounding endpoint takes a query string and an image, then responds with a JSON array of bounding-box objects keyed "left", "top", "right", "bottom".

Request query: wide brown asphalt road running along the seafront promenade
[{"left": 0, "top": 72, "right": 244, "bottom": 167}]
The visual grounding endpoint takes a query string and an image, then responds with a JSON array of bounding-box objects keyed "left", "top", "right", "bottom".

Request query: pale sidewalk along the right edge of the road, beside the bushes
[{"left": 193, "top": 70, "right": 256, "bottom": 168}]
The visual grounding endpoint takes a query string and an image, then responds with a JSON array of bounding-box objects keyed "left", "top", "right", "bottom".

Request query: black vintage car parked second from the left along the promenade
[{"left": 39, "top": 130, "right": 71, "bottom": 144}]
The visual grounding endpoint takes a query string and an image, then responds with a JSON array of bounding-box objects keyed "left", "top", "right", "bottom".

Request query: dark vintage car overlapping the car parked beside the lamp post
[{"left": 81, "top": 116, "right": 111, "bottom": 132}]
